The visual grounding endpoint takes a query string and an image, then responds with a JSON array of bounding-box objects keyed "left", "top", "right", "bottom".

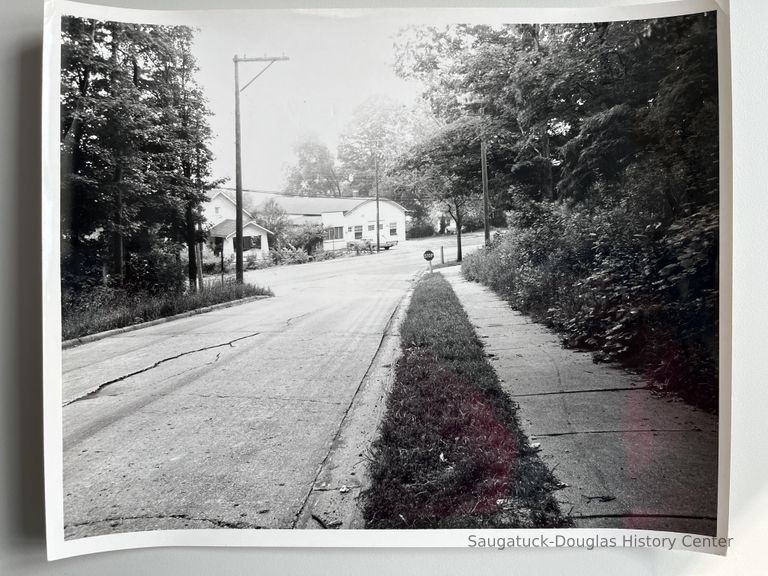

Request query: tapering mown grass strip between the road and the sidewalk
[{"left": 363, "top": 274, "right": 570, "bottom": 528}]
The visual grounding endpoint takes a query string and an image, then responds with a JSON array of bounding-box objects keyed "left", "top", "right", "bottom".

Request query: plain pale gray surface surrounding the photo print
[{"left": 0, "top": 0, "right": 768, "bottom": 576}]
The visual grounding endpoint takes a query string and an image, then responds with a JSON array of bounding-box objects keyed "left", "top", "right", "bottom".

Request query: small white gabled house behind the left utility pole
[{"left": 203, "top": 190, "right": 271, "bottom": 260}]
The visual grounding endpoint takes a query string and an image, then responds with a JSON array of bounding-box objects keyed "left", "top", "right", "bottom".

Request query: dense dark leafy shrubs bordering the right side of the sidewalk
[{"left": 462, "top": 201, "right": 718, "bottom": 409}]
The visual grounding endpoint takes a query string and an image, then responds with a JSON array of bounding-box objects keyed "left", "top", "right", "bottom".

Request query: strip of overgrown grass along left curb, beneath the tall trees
[{"left": 62, "top": 283, "right": 273, "bottom": 340}]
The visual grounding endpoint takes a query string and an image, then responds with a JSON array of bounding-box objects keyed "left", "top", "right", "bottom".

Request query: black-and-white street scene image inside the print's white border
[{"left": 43, "top": 4, "right": 730, "bottom": 560}]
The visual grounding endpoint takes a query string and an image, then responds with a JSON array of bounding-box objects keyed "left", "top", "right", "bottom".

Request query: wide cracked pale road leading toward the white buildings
[{"left": 63, "top": 234, "right": 482, "bottom": 538}]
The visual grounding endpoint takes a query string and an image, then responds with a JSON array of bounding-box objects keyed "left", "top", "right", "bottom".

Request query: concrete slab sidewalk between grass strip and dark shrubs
[{"left": 440, "top": 266, "right": 718, "bottom": 535}]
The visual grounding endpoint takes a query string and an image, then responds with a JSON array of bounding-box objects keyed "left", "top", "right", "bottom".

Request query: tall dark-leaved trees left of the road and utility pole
[{"left": 61, "top": 17, "right": 219, "bottom": 289}]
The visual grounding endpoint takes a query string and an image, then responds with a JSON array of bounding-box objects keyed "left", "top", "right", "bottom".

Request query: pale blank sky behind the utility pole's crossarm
[{"left": 193, "top": 11, "right": 423, "bottom": 190}]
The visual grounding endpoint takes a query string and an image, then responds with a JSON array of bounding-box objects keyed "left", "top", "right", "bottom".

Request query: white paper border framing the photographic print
[{"left": 42, "top": 0, "right": 733, "bottom": 560}]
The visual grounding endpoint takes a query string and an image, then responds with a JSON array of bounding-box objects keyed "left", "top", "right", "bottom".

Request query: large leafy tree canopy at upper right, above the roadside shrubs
[{"left": 396, "top": 14, "right": 717, "bottom": 215}]
